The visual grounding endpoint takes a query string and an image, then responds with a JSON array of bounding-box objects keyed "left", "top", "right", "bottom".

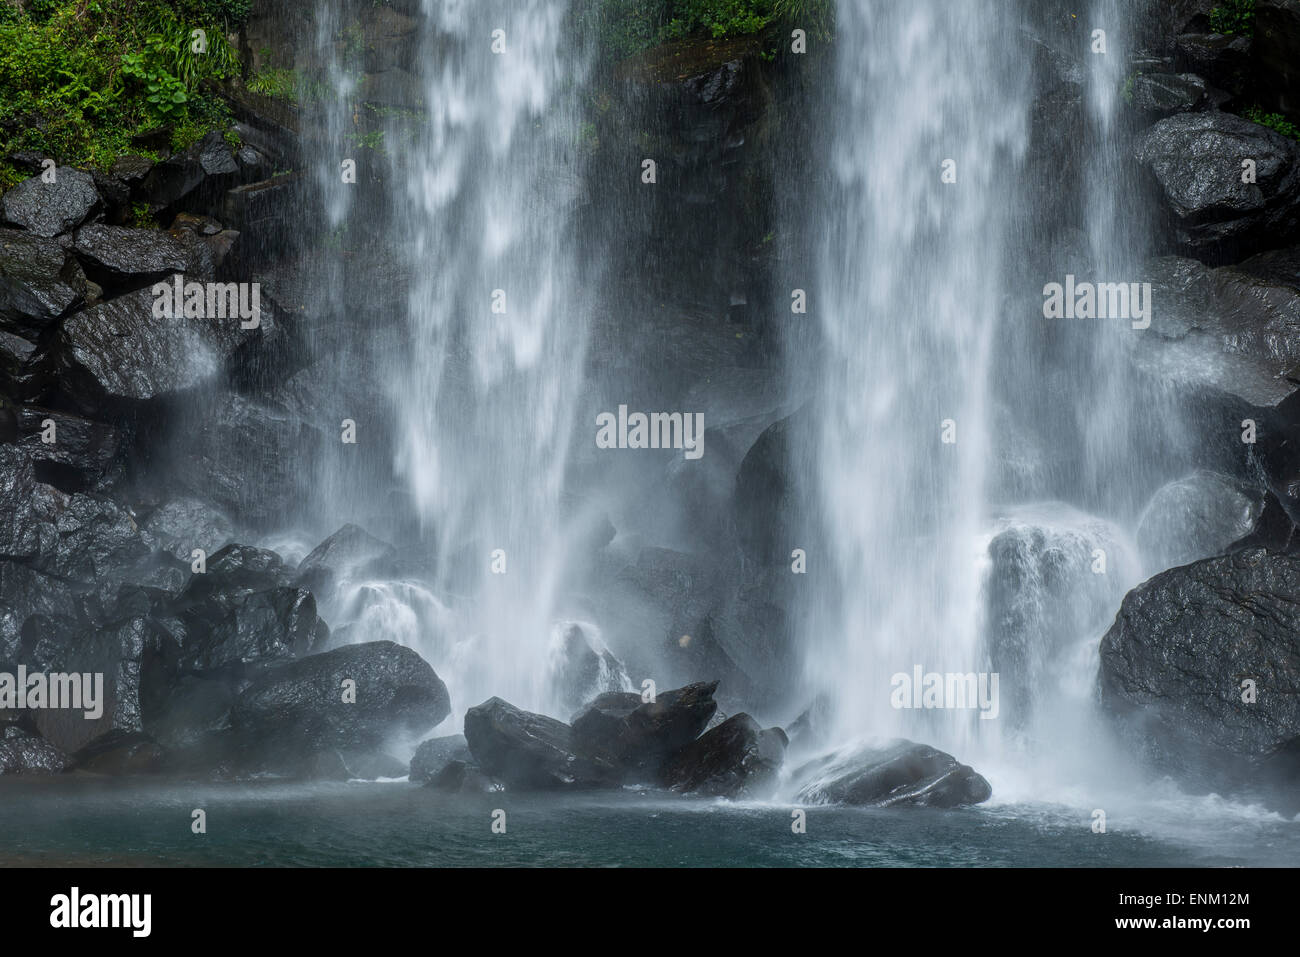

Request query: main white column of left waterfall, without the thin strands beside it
[{"left": 389, "top": 0, "right": 590, "bottom": 720}]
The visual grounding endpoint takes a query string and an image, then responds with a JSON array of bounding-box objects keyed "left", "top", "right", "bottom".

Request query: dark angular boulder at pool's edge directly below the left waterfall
[{"left": 465, "top": 698, "right": 621, "bottom": 789}]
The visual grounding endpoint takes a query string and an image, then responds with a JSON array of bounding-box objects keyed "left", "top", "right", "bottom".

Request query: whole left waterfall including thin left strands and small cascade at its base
[{"left": 301, "top": 0, "right": 598, "bottom": 720}]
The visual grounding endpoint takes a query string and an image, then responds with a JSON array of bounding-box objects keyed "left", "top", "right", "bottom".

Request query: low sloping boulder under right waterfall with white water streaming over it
[{"left": 794, "top": 740, "right": 993, "bottom": 807}]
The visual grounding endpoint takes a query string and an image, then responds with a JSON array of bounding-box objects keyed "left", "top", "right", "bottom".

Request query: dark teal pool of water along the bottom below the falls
[{"left": 0, "top": 778, "right": 1300, "bottom": 867}]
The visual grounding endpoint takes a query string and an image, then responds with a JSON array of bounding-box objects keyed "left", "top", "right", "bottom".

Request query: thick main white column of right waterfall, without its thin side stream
[{"left": 806, "top": 0, "right": 1030, "bottom": 753}]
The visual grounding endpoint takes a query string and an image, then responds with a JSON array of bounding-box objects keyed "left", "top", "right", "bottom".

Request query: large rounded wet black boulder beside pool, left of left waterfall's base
[{"left": 230, "top": 641, "right": 451, "bottom": 759}]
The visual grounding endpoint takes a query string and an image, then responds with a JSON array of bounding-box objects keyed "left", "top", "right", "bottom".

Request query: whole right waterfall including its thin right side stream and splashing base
[{"left": 805, "top": 0, "right": 1183, "bottom": 768}]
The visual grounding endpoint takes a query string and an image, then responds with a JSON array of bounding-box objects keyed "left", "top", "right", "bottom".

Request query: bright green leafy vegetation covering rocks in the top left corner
[{"left": 0, "top": 0, "right": 251, "bottom": 185}]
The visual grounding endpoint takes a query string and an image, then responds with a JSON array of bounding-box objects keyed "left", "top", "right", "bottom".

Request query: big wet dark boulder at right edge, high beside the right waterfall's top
[{"left": 1136, "top": 112, "right": 1300, "bottom": 261}]
